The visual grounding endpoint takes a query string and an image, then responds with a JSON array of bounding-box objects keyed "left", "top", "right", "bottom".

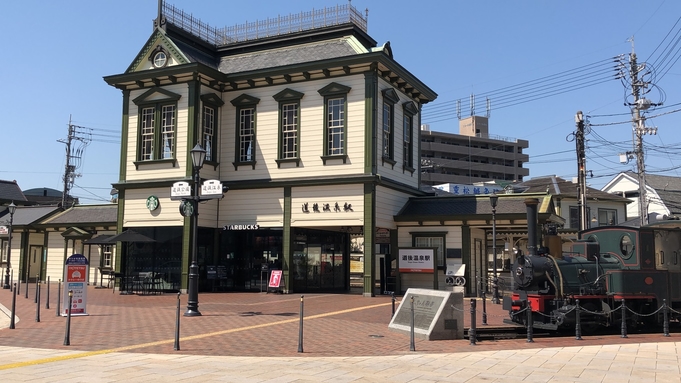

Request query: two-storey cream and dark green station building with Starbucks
[{"left": 105, "top": 2, "right": 436, "bottom": 296}]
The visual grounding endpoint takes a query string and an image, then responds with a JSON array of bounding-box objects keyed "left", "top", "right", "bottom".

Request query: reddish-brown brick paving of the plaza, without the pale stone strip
[{"left": 0, "top": 284, "right": 681, "bottom": 357}]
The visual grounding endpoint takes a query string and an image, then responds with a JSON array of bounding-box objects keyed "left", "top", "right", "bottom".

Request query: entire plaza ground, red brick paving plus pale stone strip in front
[{"left": 0, "top": 284, "right": 681, "bottom": 382}]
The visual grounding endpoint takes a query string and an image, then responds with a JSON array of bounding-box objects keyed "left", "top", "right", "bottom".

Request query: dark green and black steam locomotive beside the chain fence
[{"left": 503, "top": 220, "right": 681, "bottom": 331}]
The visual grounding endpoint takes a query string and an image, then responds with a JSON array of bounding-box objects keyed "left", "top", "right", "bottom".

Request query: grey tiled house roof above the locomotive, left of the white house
[{"left": 515, "top": 176, "right": 631, "bottom": 203}]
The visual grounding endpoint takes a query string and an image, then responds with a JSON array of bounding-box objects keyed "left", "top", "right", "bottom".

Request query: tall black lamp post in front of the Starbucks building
[{"left": 184, "top": 144, "right": 206, "bottom": 317}]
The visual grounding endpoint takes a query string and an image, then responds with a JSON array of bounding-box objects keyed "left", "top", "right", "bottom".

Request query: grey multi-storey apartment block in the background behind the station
[{"left": 421, "top": 116, "right": 530, "bottom": 185}]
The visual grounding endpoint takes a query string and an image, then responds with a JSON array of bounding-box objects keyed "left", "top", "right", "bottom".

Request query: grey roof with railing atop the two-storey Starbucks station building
[{"left": 104, "top": 5, "right": 437, "bottom": 104}]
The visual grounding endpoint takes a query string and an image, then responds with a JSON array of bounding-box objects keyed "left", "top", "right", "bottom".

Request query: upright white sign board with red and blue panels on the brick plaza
[{"left": 59, "top": 254, "right": 88, "bottom": 316}]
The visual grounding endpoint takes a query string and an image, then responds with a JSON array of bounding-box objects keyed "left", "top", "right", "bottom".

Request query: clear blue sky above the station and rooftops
[{"left": 0, "top": 0, "right": 681, "bottom": 204}]
